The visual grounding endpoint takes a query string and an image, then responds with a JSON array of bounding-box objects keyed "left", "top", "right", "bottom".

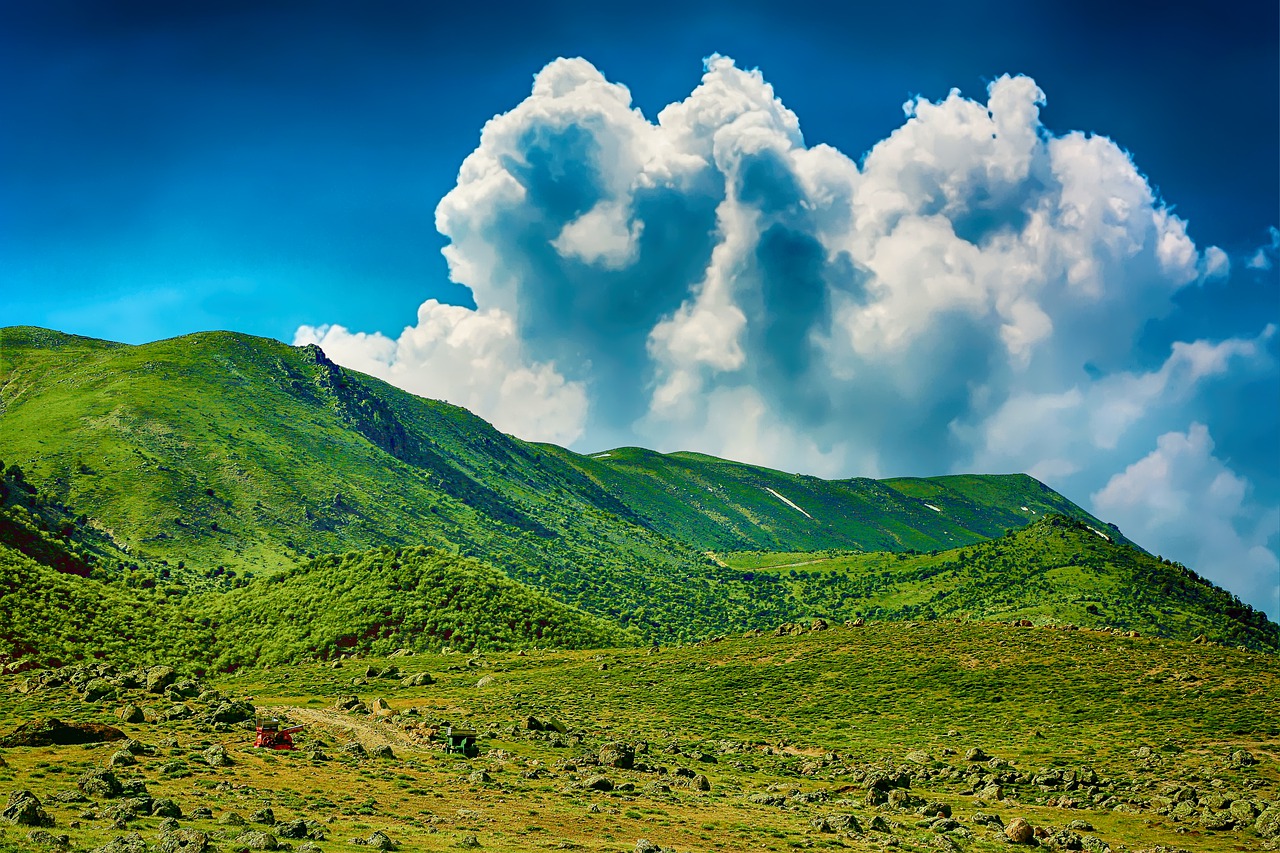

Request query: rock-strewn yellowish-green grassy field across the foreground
[{"left": 0, "top": 621, "right": 1280, "bottom": 853}]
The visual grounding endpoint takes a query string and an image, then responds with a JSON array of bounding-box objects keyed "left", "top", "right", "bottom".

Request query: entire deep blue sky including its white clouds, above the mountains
[{"left": 0, "top": 0, "right": 1280, "bottom": 615}]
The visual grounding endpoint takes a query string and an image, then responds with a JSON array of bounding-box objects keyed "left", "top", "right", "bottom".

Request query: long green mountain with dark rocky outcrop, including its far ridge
[{"left": 0, "top": 322, "right": 1264, "bottom": 640}]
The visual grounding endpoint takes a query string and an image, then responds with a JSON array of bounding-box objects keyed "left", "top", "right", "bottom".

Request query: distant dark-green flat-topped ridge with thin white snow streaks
[{"left": 547, "top": 447, "right": 1126, "bottom": 551}]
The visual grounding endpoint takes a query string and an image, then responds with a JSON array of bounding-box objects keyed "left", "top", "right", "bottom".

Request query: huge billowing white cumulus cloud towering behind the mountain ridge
[{"left": 298, "top": 55, "right": 1275, "bottom": 612}]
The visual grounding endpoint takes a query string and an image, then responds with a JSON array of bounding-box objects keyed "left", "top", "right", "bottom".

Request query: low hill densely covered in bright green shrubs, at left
[{"left": 0, "top": 544, "right": 639, "bottom": 670}]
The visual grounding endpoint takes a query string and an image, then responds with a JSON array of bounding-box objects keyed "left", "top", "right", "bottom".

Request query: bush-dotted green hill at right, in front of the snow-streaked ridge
[{"left": 724, "top": 515, "right": 1280, "bottom": 649}]
